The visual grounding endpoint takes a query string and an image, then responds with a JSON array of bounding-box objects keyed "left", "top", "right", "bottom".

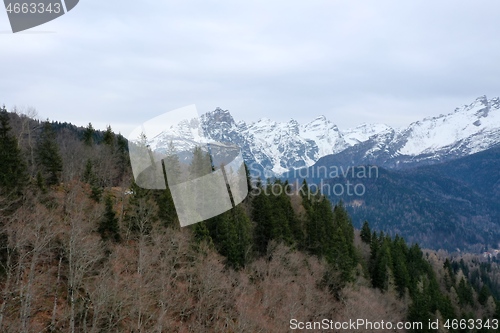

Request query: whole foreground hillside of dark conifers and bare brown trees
[{"left": 0, "top": 107, "right": 500, "bottom": 333}]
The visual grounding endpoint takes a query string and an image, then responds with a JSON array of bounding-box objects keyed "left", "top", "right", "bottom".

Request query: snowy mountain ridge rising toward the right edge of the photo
[{"left": 317, "top": 96, "right": 500, "bottom": 169}]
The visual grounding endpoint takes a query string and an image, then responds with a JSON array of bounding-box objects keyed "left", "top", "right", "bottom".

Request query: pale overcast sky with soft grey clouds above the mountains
[{"left": 0, "top": 0, "right": 500, "bottom": 135}]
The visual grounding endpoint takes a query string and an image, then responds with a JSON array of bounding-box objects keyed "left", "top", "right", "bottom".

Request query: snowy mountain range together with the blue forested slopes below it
[{"left": 146, "top": 96, "right": 500, "bottom": 252}]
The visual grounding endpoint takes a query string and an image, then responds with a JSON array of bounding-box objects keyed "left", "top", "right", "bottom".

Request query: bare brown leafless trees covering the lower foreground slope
[{"left": 0, "top": 182, "right": 410, "bottom": 333}]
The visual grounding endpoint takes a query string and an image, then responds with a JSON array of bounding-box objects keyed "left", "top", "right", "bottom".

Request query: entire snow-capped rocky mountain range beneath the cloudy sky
[{"left": 150, "top": 96, "right": 500, "bottom": 177}]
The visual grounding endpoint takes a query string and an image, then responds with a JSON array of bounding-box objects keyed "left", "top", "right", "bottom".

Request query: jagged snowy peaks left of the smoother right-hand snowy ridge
[{"left": 149, "top": 108, "right": 380, "bottom": 176}]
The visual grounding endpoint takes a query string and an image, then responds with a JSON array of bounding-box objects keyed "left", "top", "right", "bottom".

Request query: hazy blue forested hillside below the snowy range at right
[{"left": 287, "top": 146, "right": 500, "bottom": 253}]
